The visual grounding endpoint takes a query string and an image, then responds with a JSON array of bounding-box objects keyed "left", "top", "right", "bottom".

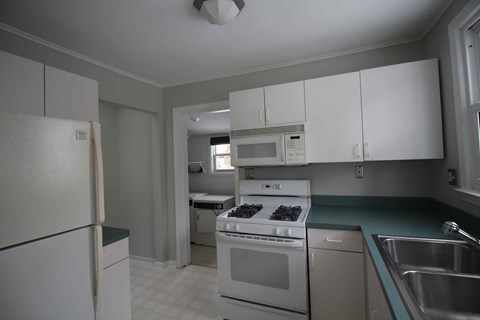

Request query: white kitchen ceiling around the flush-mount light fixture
[{"left": 0, "top": 0, "right": 452, "bottom": 87}]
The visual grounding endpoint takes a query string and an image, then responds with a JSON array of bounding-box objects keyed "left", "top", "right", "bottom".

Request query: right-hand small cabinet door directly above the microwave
[{"left": 265, "top": 81, "right": 305, "bottom": 126}]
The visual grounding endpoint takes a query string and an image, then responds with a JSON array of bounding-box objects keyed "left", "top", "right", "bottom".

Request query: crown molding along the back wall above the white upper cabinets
[{"left": 163, "top": 36, "right": 423, "bottom": 88}]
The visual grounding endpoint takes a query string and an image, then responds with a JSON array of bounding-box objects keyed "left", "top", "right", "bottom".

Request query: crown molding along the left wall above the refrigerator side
[{"left": 0, "top": 22, "right": 163, "bottom": 88}]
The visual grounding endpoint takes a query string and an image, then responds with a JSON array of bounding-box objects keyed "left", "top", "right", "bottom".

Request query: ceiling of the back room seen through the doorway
[{"left": 186, "top": 110, "right": 230, "bottom": 136}]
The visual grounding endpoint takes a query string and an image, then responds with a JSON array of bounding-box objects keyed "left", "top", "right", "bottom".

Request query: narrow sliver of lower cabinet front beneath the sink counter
[{"left": 366, "top": 251, "right": 393, "bottom": 320}]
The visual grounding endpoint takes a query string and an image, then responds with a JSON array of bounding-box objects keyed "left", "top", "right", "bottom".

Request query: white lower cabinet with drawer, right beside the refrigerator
[{"left": 103, "top": 238, "right": 132, "bottom": 320}]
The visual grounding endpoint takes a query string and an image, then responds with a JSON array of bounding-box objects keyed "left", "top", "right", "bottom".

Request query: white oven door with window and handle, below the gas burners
[{"left": 216, "top": 232, "right": 308, "bottom": 313}]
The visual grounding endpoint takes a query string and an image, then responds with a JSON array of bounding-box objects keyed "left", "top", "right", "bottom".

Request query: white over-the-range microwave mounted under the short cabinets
[{"left": 230, "top": 124, "right": 307, "bottom": 167}]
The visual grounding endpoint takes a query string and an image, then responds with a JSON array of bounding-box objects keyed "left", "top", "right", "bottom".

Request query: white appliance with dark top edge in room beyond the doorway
[{"left": 193, "top": 195, "right": 235, "bottom": 247}]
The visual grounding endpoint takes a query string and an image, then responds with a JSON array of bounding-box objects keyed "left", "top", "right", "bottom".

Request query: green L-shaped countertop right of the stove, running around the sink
[{"left": 306, "top": 197, "right": 480, "bottom": 320}]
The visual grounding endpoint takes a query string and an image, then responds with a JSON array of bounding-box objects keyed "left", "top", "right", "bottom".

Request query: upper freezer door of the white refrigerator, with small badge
[{"left": 0, "top": 113, "right": 97, "bottom": 249}]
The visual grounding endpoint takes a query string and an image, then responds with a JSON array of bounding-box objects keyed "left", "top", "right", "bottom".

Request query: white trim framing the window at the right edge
[{"left": 448, "top": 0, "right": 480, "bottom": 190}]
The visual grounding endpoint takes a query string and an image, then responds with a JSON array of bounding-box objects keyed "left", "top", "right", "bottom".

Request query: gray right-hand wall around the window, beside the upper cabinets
[{"left": 423, "top": 0, "right": 480, "bottom": 217}]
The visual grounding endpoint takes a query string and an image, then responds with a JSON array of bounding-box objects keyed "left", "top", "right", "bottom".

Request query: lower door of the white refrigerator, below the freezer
[{"left": 0, "top": 227, "right": 95, "bottom": 320}]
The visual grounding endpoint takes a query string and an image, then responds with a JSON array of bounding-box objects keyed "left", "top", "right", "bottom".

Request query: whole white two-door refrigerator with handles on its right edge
[{"left": 0, "top": 113, "right": 104, "bottom": 320}]
